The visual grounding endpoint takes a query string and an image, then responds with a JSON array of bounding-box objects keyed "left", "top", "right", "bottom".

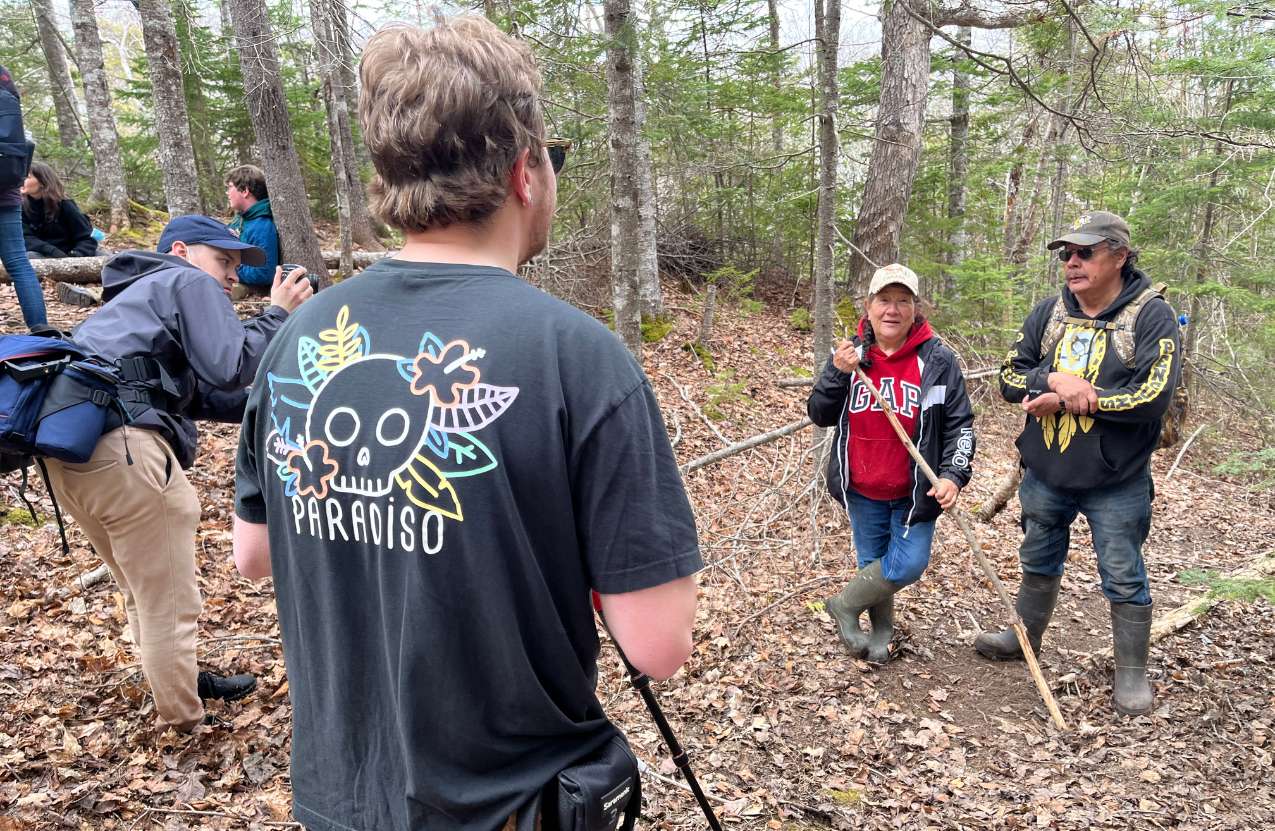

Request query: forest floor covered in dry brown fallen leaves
[{"left": 0, "top": 268, "right": 1275, "bottom": 831}]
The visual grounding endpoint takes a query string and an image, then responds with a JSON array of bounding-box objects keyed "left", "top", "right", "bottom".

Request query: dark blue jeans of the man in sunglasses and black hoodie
[{"left": 1019, "top": 468, "right": 1155, "bottom": 605}]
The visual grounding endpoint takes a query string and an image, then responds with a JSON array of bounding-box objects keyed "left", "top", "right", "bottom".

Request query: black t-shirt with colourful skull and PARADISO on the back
[{"left": 236, "top": 260, "right": 703, "bottom": 831}]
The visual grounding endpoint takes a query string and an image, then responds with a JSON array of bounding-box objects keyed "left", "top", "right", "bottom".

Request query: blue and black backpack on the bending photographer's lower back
[{"left": 0, "top": 335, "right": 133, "bottom": 551}]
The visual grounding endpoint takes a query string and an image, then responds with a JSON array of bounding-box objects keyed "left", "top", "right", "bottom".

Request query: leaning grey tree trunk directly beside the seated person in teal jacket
[{"left": 228, "top": 0, "right": 326, "bottom": 274}]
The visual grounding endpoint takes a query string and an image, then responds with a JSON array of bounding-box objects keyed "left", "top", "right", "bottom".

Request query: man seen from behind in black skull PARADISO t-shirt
[{"left": 235, "top": 18, "right": 703, "bottom": 831}]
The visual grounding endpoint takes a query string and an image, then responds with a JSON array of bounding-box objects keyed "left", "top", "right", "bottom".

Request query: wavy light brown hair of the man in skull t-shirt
[{"left": 358, "top": 17, "right": 544, "bottom": 232}]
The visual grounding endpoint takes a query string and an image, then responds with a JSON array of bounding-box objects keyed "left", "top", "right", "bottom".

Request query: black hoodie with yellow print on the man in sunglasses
[{"left": 1001, "top": 269, "right": 1182, "bottom": 489}]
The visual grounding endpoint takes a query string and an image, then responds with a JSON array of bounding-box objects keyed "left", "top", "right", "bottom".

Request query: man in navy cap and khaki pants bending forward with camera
[{"left": 47, "top": 215, "right": 312, "bottom": 730}]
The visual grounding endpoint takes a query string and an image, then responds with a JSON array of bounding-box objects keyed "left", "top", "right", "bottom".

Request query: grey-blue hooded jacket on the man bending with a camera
[{"left": 71, "top": 251, "right": 288, "bottom": 468}]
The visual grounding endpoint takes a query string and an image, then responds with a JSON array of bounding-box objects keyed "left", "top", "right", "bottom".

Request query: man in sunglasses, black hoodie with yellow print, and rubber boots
[{"left": 974, "top": 210, "right": 1181, "bottom": 715}]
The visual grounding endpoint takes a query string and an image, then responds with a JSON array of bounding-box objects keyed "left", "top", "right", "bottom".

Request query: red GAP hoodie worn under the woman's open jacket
[{"left": 843, "top": 320, "right": 935, "bottom": 501}]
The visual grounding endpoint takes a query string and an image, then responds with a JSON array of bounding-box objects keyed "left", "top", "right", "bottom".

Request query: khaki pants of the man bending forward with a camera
[{"left": 47, "top": 428, "right": 204, "bottom": 730}]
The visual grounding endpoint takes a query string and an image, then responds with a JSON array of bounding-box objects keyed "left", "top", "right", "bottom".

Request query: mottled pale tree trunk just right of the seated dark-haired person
[{"left": 70, "top": 0, "right": 131, "bottom": 233}]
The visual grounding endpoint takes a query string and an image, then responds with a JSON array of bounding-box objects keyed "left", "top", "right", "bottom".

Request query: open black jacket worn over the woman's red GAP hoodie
[{"left": 806, "top": 338, "right": 977, "bottom": 525}]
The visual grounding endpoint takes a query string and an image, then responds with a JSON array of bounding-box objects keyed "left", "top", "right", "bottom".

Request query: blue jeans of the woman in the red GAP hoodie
[{"left": 845, "top": 491, "right": 935, "bottom": 588}]
